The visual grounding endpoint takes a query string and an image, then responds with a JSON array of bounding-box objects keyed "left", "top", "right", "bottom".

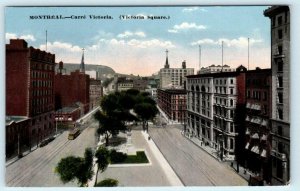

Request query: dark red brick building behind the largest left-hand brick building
[{"left": 54, "top": 62, "right": 90, "bottom": 113}]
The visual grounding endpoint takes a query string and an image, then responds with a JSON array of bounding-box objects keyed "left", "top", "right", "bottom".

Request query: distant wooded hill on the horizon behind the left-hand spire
[{"left": 56, "top": 63, "right": 116, "bottom": 78}]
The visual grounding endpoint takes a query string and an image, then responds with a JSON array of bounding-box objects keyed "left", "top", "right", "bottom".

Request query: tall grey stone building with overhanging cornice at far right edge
[{"left": 264, "top": 6, "right": 290, "bottom": 184}]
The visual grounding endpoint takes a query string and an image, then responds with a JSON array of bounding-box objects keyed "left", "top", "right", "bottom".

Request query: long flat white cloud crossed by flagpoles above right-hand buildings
[{"left": 191, "top": 37, "right": 263, "bottom": 47}]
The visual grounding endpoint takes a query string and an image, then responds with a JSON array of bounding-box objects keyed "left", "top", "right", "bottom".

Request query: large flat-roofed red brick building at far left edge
[{"left": 6, "top": 39, "right": 55, "bottom": 152}]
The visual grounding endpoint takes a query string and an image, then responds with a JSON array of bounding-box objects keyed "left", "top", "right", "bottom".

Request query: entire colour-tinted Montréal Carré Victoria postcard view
[{"left": 5, "top": 5, "right": 290, "bottom": 187}]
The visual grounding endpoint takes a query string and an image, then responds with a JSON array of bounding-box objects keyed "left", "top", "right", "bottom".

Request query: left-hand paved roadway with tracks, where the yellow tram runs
[{"left": 5, "top": 122, "right": 98, "bottom": 187}]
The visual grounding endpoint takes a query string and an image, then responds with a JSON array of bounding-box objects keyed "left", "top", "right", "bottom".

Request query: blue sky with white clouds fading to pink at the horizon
[{"left": 4, "top": 6, "right": 271, "bottom": 76}]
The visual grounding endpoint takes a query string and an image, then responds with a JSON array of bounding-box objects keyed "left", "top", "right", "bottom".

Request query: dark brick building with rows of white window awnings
[{"left": 243, "top": 68, "right": 272, "bottom": 183}]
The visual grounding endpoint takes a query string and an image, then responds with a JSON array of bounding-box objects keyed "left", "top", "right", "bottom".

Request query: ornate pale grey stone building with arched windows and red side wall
[{"left": 185, "top": 66, "right": 246, "bottom": 160}]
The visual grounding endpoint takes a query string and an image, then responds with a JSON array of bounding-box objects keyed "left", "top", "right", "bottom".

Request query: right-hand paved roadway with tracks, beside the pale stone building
[{"left": 149, "top": 125, "right": 247, "bottom": 186}]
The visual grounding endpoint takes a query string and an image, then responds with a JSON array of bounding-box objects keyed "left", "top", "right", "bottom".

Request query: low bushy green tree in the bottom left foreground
[{"left": 55, "top": 148, "right": 93, "bottom": 186}]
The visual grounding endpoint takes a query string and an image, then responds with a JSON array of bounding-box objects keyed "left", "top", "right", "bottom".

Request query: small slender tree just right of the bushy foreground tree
[{"left": 95, "top": 146, "right": 109, "bottom": 185}]
